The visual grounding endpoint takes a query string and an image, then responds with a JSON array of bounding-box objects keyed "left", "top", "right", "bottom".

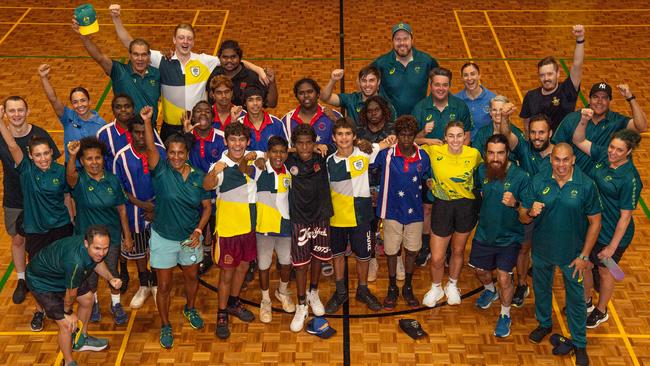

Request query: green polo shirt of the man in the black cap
[{"left": 551, "top": 111, "right": 630, "bottom": 172}]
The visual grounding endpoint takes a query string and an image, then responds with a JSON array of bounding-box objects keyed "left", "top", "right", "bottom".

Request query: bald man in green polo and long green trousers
[{"left": 519, "top": 143, "right": 601, "bottom": 365}]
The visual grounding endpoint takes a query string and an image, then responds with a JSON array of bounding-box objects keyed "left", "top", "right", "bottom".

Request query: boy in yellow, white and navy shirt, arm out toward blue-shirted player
[{"left": 325, "top": 117, "right": 395, "bottom": 314}]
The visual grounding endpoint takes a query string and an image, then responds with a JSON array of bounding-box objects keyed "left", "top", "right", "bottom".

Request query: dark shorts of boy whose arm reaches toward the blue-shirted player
[{"left": 330, "top": 224, "right": 373, "bottom": 261}]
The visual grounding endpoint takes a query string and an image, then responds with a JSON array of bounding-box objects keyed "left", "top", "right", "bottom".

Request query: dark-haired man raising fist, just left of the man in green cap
[{"left": 320, "top": 65, "right": 397, "bottom": 127}]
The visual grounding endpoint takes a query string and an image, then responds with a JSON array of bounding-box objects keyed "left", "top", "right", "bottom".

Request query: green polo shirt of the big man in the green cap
[{"left": 372, "top": 47, "right": 438, "bottom": 117}]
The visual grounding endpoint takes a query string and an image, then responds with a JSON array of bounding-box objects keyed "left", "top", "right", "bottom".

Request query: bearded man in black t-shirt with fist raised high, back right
[{"left": 519, "top": 24, "right": 585, "bottom": 133}]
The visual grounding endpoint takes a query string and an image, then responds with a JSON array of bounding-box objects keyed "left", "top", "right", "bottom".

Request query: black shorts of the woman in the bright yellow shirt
[{"left": 431, "top": 198, "right": 478, "bottom": 237}]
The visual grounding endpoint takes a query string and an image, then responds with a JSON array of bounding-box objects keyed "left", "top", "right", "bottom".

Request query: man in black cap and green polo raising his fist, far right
[{"left": 551, "top": 81, "right": 648, "bottom": 172}]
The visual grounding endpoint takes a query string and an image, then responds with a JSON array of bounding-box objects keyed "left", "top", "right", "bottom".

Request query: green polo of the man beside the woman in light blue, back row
[{"left": 411, "top": 94, "right": 474, "bottom": 140}]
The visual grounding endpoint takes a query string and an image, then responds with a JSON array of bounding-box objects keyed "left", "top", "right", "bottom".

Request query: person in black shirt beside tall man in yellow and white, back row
[{"left": 206, "top": 39, "right": 278, "bottom": 108}]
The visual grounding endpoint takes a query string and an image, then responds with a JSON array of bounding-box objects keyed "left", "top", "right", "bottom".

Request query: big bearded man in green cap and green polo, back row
[{"left": 372, "top": 22, "right": 438, "bottom": 117}]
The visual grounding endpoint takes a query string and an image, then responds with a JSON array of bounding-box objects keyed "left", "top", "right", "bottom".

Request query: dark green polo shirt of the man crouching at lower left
[{"left": 26, "top": 235, "right": 97, "bottom": 292}]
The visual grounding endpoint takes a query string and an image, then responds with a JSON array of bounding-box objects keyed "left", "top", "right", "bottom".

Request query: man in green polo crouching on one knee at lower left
[{"left": 27, "top": 225, "right": 122, "bottom": 365}]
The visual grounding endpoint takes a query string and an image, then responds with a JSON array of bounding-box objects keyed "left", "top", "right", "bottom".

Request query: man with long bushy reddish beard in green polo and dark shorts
[{"left": 469, "top": 134, "right": 529, "bottom": 338}]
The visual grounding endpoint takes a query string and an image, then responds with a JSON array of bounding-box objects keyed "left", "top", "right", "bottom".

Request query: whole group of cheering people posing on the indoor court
[{"left": 0, "top": 5, "right": 647, "bottom": 365}]
